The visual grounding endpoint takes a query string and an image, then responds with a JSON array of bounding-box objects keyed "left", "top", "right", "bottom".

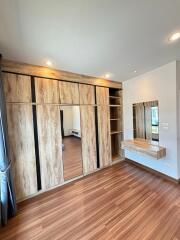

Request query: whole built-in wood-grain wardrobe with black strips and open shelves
[{"left": 3, "top": 59, "right": 123, "bottom": 201}]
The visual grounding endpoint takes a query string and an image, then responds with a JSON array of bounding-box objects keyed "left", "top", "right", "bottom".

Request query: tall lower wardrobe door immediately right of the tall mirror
[{"left": 80, "top": 106, "right": 97, "bottom": 174}]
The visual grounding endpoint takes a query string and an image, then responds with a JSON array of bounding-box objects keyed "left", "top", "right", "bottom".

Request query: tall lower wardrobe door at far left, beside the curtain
[{"left": 7, "top": 104, "right": 37, "bottom": 200}]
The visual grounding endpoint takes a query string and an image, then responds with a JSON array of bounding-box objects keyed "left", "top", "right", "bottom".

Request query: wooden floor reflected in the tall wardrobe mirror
[{"left": 63, "top": 136, "right": 83, "bottom": 180}]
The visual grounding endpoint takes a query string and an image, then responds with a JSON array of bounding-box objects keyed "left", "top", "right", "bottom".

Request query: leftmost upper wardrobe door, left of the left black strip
[{"left": 3, "top": 73, "right": 31, "bottom": 103}]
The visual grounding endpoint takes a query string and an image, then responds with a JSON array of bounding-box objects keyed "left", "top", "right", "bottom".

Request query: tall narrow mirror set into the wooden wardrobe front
[{"left": 60, "top": 106, "right": 83, "bottom": 180}]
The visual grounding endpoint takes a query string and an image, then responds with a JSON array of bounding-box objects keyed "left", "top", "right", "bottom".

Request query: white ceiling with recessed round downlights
[{"left": 0, "top": 0, "right": 180, "bottom": 81}]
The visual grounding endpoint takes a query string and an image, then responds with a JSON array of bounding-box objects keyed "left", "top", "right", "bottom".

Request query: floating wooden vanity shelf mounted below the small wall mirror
[{"left": 121, "top": 138, "right": 166, "bottom": 160}]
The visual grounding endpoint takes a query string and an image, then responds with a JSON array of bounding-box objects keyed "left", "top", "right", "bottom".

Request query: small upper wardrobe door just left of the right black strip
[{"left": 79, "top": 84, "right": 95, "bottom": 105}]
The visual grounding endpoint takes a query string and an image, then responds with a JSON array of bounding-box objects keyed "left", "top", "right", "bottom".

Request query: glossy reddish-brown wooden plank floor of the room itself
[{"left": 0, "top": 163, "right": 180, "bottom": 240}]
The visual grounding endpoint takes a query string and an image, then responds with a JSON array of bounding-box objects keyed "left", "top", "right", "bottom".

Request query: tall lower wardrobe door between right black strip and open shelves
[{"left": 97, "top": 106, "right": 112, "bottom": 168}]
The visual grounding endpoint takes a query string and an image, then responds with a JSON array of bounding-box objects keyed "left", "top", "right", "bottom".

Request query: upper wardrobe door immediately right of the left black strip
[{"left": 35, "top": 78, "right": 59, "bottom": 103}]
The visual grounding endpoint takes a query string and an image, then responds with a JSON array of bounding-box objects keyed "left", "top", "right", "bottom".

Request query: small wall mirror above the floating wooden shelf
[{"left": 133, "top": 101, "right": 159, "bottom": 141}]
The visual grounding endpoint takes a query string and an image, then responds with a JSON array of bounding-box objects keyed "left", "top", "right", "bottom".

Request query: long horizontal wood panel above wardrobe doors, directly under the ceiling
[{"left": 2, "top": 59, "right": 122, "bottom": 88}]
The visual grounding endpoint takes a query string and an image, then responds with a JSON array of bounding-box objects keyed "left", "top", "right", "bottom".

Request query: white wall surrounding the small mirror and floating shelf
[{"left": 123, "top": 62, "right": 180, "bottom": 179}]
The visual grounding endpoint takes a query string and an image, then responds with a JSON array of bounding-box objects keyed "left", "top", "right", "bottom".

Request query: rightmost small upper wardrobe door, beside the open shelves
[{"left": 96, "top": 87, "right": 109, "bottom": 105}]
